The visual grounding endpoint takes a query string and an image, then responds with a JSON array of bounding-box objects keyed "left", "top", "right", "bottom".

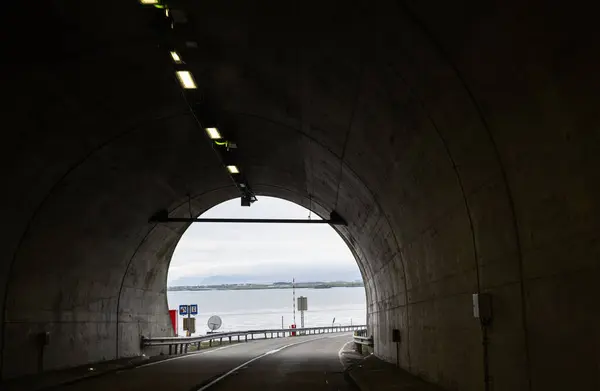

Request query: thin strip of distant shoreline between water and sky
[{"left": 167, "top": 281, "right": 365, "bottom": 292}]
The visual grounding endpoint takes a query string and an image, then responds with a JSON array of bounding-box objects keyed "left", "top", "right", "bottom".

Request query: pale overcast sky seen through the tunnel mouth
[{"left": 168, "top": 197, "right": 361, "bottom": 285}]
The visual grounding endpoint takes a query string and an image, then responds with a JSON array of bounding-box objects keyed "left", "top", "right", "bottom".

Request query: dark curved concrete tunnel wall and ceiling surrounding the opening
[{"left": 0, "top": 0, "right": 600, "bottom": 391}]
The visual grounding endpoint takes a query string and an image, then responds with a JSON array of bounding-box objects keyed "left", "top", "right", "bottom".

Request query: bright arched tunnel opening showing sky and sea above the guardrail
[{"left": 167, "top": 197, "right": 366, "bottom": 335}]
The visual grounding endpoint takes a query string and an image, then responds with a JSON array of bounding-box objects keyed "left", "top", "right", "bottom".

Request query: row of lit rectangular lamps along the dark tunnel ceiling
[{"left": 139, "top": 0, "right": 256, "bottom": 206}]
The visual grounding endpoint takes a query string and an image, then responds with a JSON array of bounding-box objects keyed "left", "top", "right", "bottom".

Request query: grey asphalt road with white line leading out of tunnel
[{"left": 62, "top": 333, "right": 354, "bottom": 391}]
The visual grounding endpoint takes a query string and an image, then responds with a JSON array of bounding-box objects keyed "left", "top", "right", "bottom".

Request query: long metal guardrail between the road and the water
[{"left": 142, "top": 325, "right": 367, "bottom": 354}]
